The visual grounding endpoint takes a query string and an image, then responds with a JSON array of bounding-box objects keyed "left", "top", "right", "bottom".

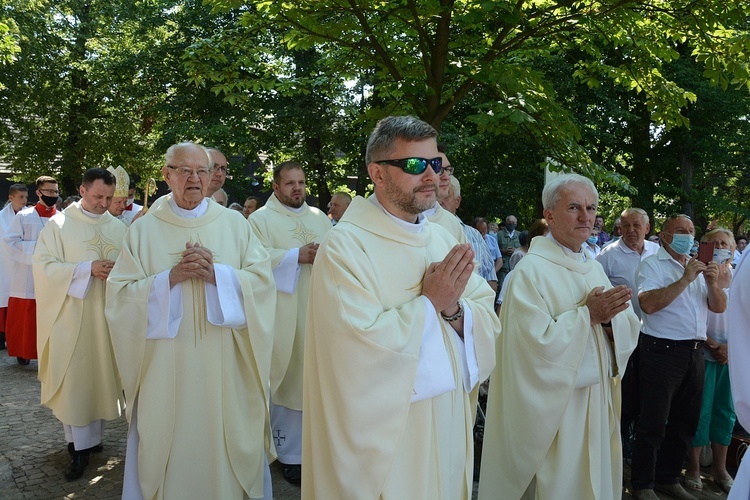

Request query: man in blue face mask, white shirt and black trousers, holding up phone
[{"left": 631, "top": 215, "right": 728, "bottom": 500}]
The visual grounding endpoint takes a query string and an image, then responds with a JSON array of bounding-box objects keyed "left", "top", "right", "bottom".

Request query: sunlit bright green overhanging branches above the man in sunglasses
[{"left": 190, "top": 0, "right": 748, "bottom": 209}]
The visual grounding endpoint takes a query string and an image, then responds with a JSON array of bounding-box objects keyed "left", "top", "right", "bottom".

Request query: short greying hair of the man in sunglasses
[{"left": 365, "top": 116, "right": 437, "bottom": 166}]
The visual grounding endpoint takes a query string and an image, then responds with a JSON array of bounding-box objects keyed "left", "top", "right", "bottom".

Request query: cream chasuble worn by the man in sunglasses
[{"left": 302, "top": 197, "right": 500, "bottom": 500}]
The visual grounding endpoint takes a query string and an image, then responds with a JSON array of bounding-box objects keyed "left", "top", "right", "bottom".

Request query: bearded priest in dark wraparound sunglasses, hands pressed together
[{"left": 302, "top": 117, "right": 500, "bottom": 500}]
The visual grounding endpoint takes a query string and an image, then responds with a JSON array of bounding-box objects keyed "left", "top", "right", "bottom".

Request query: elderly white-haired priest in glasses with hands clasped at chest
[{"left": 106, "top": 143, "right": 276, "bottom": 499}]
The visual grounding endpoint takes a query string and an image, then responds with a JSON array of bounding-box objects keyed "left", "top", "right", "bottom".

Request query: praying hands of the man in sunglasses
[{"left": 422, "top": 244, "right": 474, "bottom": 316}]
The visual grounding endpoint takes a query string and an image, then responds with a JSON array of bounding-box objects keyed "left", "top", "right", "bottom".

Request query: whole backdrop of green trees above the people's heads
[{"left": 0, "top": 0, "right": 750, "bottom": 227}]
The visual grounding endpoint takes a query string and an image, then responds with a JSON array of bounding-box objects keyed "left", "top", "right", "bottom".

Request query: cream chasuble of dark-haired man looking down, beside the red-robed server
[{"left": 33, "top": 202, "right": 126, "bottom": 427}]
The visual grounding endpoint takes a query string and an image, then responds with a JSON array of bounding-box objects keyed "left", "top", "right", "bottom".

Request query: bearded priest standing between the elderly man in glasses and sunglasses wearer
[{"left": 248, "top": 161, "right": 331, "bottom": 485}]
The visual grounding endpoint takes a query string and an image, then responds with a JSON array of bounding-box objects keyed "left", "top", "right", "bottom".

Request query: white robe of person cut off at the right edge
[{"left": 727, "top": 251, "right": 750, "bottom": 500}]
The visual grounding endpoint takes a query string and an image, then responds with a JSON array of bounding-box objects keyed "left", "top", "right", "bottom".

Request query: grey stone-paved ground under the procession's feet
[{"left": 0, "top": 351, "right": 726, "bottom": 500}]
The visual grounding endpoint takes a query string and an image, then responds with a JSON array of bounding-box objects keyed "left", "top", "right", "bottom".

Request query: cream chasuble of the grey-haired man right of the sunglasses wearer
[{"left": 479, "top": 238, "right": 639, "bottom": 500}]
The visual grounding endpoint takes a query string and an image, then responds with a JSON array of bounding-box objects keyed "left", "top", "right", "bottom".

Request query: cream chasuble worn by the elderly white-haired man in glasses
[{"left": 106, "top": 195, "right": 276, "bottom": 499}]
